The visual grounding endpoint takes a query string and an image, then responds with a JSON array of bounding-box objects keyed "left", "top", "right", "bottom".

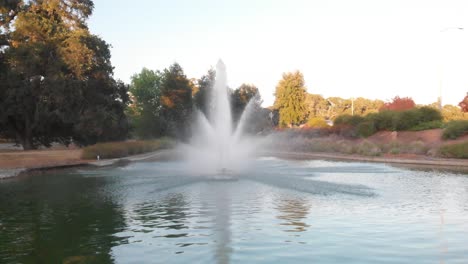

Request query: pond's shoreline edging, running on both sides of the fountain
[{"left": 0, "top": 149, "right": 468, "bottom": 180}]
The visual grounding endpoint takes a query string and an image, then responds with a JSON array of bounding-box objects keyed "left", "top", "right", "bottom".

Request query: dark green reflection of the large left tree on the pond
[{"left": 0, "top": 174, "right": 125, "bottom": 263}]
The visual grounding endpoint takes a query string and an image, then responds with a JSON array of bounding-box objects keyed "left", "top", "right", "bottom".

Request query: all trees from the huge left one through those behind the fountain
[{"left": 0, "top": 0, "right": 271, "bottom": 149}]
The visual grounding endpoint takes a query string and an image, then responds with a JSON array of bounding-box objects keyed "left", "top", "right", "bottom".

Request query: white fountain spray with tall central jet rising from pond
[{"left": 183, "top": 60, "right": 255, "bottom": 177}]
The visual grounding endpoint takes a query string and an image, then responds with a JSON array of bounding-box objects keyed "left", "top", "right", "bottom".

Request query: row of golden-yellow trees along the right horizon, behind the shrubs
[{"left": 272, "top": 71, "right": 468, "bottom": 130}]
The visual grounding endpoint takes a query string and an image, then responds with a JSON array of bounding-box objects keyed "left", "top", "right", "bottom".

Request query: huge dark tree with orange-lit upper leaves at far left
[{"left": 0, "top": 0, "right": 128, "bottom": 149}]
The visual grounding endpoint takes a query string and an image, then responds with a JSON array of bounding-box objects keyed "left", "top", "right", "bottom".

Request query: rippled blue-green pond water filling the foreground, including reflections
[{"left": 0, "top": 158, "right": 468, "bottom": 263}]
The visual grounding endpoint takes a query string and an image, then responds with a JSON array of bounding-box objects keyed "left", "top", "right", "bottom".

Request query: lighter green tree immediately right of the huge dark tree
[{"left": 127, "top": 68, "right": 164, "bottom": 138}]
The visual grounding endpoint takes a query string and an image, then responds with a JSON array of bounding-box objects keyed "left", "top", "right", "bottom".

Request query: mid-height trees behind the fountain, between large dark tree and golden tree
[{"left": 126, "top": 63, "right": 272, "bottom": 140}]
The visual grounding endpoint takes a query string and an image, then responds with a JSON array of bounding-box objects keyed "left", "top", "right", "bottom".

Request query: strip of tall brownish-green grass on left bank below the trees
[{"left": 81, "top": 138, "right": 174, "bottom": 159}]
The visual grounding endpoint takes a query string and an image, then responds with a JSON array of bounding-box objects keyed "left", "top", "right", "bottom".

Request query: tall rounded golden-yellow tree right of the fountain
[{"left": 274, "top": 71, "right": 307, "bottom": 127}]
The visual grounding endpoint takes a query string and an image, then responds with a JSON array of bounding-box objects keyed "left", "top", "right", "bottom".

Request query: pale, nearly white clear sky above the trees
[{"left": 88, "top": 0, "right": 468, "bottom": 106}]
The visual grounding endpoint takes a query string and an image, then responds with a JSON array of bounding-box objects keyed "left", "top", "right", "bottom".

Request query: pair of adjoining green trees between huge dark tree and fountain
[{"left": 127, "top": 63, "right": 193, "bottom": 139}]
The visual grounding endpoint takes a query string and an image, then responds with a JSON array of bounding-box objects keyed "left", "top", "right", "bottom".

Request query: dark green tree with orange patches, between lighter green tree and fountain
[{"left": 160, "top": 63, "right": 193, "bottom": 138}]
